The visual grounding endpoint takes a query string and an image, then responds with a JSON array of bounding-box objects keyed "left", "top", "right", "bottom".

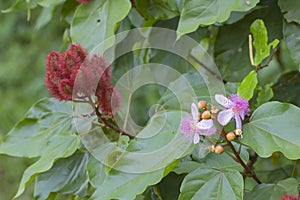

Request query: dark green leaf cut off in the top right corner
[{"left": 278, "top": 0, "right": 300, "bottom": 23}]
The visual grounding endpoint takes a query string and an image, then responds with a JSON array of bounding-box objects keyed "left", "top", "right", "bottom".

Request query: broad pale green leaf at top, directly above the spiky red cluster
[{"left": 71, "top": 0, "right": 131, "bottom": 50}]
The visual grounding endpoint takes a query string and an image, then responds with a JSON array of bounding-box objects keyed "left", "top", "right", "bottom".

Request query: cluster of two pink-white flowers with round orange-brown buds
[{"left": 180, "top": 94, "right": 250, "bottom": 146}]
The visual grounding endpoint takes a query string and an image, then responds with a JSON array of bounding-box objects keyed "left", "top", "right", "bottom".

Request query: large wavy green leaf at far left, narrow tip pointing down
[{"left": 0, "top": 98, "right": 80, "bottom": 198}]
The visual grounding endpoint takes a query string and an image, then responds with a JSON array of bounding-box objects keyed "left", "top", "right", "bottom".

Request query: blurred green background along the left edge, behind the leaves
[{"left": 0, "top": 0, "right": 63, "bottom": 200}]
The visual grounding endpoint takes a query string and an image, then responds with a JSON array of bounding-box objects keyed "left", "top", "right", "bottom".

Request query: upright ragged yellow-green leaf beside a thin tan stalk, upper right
[{"left": 250, "top": 19, "right": 279, "bottom": 66}]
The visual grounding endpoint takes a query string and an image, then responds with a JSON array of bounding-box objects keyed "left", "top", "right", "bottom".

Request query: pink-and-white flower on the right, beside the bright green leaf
[{"left": 215, "top": 94, "right": 250, "bottom": 129}]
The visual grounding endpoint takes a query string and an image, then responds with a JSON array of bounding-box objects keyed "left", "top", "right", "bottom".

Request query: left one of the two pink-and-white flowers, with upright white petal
[{"left": 180, "top": 103, "right": 216, "bottom": 144}]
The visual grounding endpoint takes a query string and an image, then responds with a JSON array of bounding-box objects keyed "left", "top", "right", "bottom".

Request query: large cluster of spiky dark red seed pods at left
[{"left": 45, "top": 44, "right": 120, "bottom": 113}]
